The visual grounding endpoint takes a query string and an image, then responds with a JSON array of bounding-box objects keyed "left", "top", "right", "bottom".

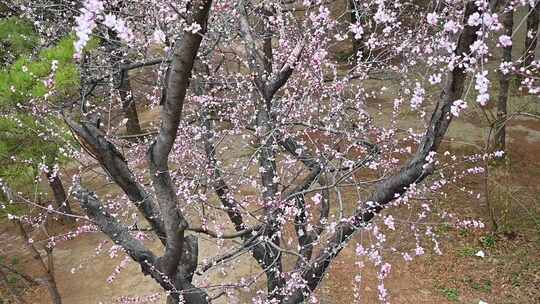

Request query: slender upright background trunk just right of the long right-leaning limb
[{"left": 495, "top": 3, "right": 514, "bottom": 151}]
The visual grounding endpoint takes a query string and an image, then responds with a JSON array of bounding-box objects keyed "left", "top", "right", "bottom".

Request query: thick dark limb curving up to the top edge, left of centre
[{"left": 148, "top": 0, "right": 212, "bottom": 284}]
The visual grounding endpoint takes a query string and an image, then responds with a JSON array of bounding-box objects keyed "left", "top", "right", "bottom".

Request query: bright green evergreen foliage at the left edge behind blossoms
[{"left": 0, "top": 17, "right": 79, "bottom": 196}]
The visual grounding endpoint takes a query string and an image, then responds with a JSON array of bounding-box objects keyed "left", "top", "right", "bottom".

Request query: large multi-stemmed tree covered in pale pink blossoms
[{"left": 4, "top": 0, "right": 535, "bottom": 303}]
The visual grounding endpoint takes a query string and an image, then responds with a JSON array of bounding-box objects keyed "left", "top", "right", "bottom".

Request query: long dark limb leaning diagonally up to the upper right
[{"left": 283, "top": 2, "right": 479, "bottom": 304}]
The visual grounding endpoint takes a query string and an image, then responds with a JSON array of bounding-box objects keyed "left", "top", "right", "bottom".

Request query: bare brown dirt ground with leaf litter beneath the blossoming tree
[{"left": 0, "top": 94, "right": 540, "bottom": 304}]
